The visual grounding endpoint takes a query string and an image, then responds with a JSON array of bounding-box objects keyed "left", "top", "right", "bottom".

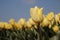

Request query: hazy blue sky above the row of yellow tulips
[{"left": 0, "top": 0, "right": 60, "bottom": 21}]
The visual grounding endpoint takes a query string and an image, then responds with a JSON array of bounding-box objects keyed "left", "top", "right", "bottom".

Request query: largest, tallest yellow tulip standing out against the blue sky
[{"left": 30, "top": 7, "right": 43, "bottom": 22}]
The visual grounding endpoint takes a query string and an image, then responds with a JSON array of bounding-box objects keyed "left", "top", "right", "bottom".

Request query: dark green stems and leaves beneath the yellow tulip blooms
[{"left": 0, "top": 26, "right": 57, "bottom": 40}]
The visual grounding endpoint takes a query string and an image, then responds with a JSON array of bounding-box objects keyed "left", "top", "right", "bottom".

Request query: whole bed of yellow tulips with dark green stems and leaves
[{"left": 0, "top": 6, "right": 60, "bottom": 40}]
